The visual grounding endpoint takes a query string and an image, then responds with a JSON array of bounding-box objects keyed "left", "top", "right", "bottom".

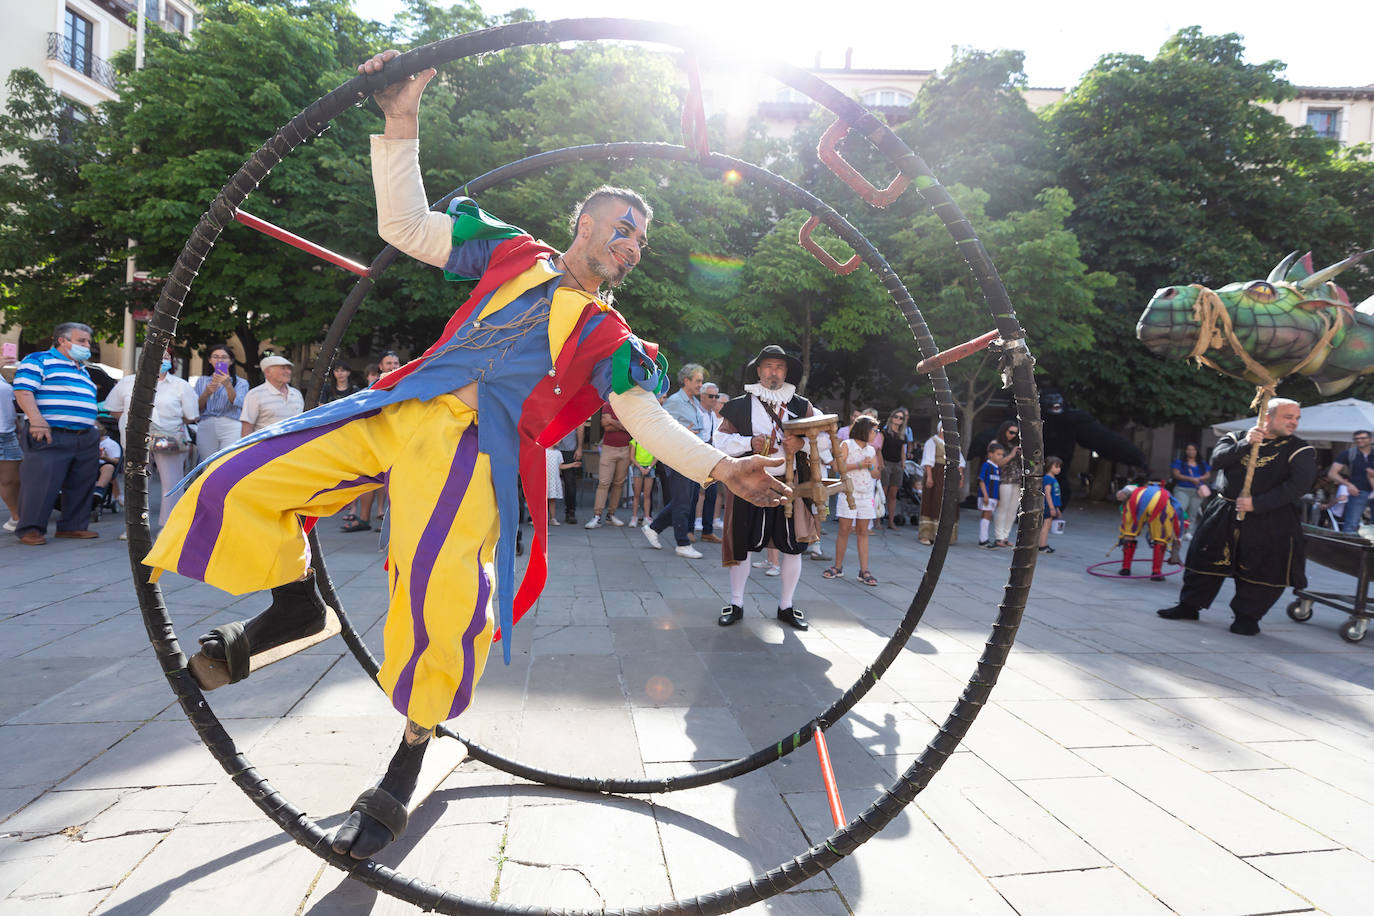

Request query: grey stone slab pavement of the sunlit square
[{"left": 0, "top": 494, "right": 1374, "bottom": 916}]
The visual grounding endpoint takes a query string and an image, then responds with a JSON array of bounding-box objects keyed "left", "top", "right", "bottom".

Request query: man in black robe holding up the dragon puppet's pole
[{"left": 1158, "top": 398, "right": 1316, "bottom": 636}]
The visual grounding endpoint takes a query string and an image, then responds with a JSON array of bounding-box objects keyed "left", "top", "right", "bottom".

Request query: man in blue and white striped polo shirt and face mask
[{"left": 14, "top": 321, "right": 100, "bottom": 545}]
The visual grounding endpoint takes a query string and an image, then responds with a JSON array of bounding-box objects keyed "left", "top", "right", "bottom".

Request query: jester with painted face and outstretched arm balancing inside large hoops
[{"left": 144, "top": 51, "right": 790, "bottom": 858}]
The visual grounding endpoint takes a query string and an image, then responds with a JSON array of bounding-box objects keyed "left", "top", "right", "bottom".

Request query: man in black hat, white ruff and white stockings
[{"left": 714, "top": 345, "right": 830, "bottom": 630}]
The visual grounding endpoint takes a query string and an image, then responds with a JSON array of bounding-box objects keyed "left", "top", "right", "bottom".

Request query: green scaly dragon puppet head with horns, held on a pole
[{"left": 1135, "top": 249, "right": 1374, "bottom": 394}]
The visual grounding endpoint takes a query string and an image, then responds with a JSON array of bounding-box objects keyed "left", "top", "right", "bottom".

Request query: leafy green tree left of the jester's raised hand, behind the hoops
[{"left": 73, "top": 0, "right": 382, "bottom": 360}]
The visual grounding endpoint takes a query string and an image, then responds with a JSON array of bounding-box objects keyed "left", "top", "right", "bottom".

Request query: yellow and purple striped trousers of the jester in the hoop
[{"left": 143, "top": 394, "right": 500, "bottom": 728}]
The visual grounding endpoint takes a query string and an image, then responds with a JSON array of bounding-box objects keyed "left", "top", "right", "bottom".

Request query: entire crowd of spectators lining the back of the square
[{"left": 8, "top": 323, "right": 1341, "bottom": 601}]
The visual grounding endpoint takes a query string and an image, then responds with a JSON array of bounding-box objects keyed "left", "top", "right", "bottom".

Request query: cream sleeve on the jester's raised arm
[{"left": 372, "top": 135, "right": 453, "bottom": 268}]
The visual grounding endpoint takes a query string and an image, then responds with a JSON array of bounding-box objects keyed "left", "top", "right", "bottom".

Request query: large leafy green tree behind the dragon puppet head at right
[{"left": 1047, "top": 27, "right": 1374, "bottom": 426}]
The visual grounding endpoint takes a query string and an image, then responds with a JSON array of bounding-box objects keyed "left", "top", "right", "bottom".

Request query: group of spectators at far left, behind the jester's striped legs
[{"left": 0, "top": 321, "right": 412, "bottom": 547}]
